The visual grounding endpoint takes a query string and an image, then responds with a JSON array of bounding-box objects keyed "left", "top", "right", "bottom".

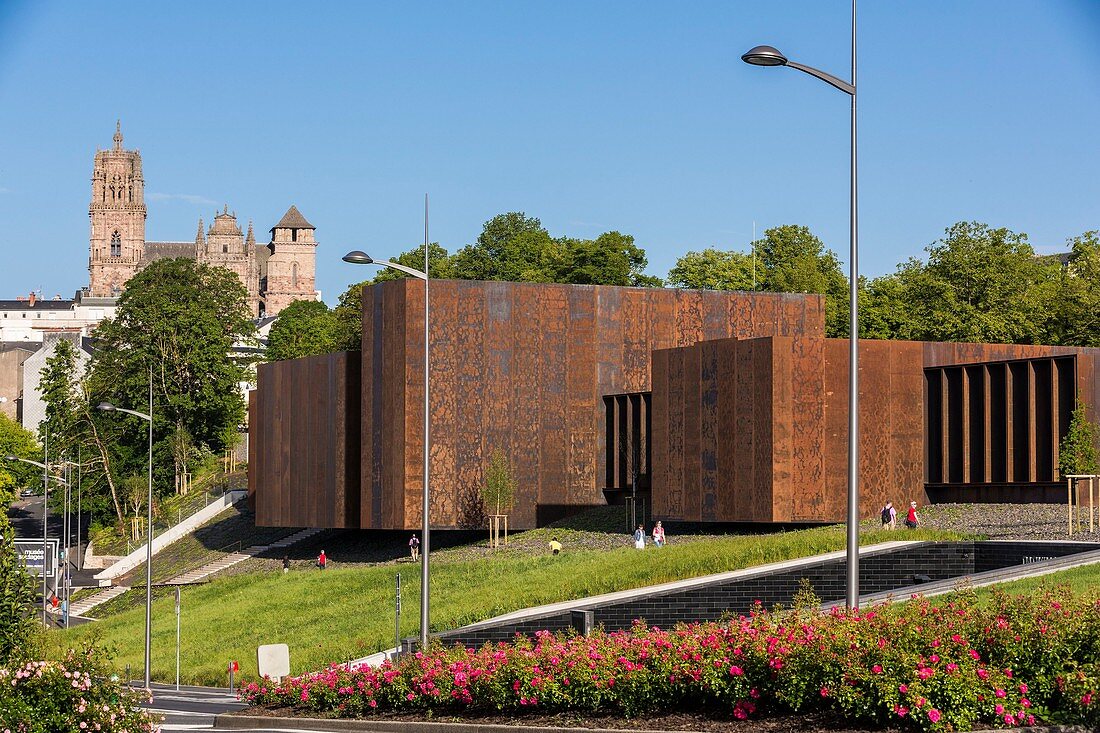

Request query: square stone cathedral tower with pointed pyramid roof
[{"left": 261, "top": 206, "right": 317, "bottom": 316}]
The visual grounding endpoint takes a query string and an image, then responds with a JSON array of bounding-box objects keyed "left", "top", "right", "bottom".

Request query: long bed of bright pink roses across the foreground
[{"left": 241, "top": 590, "right": 1100, "bottom": 731}]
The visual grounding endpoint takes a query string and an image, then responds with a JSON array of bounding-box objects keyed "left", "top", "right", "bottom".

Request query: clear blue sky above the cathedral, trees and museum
[{"left": 0, "top": 0, "right": 1100, "bottom": 303}]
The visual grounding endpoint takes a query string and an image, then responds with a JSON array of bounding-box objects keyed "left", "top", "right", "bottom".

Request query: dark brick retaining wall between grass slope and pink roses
[{"left": 438, "top": 541, "right": 1097, "bottom": 646}]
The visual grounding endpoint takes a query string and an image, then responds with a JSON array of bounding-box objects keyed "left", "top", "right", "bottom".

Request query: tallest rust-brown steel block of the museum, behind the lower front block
[{"left": 360, "top": 280, "right": 824, "bottom": 528}]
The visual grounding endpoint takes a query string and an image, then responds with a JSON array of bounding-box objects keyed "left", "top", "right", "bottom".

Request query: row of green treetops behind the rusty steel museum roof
[{"left": 267, "top": 212, "right": 1100, "bottom": 360}]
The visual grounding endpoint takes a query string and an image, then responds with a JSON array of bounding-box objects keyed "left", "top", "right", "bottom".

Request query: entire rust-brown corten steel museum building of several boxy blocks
[{"left": 249, "top": 278, "right": 1100, "bottom": 529}]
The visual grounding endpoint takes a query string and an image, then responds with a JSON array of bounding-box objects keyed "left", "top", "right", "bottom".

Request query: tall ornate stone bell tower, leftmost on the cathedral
[{"left": 88, "top": 123, "right": 145, "bottom": 297}]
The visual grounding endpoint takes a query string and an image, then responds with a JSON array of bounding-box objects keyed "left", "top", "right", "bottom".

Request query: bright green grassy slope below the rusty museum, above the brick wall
[{"left": 57, "top": 527, "right": 958, "bottom": 685}]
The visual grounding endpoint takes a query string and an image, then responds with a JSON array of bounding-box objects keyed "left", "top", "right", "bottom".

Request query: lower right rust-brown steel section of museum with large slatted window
[{"left": 652, "top": 338, "right": 1100, "bottom": 522}]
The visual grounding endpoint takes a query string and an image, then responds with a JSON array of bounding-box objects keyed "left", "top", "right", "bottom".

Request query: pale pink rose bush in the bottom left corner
[{"left": 0, "top": 650, "right": 157, "bottom": 733}]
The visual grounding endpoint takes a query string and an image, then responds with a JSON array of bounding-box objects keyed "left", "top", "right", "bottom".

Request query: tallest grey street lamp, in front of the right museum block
[{"left": 741, "top": 0, "right": 859, "bottom": 609}]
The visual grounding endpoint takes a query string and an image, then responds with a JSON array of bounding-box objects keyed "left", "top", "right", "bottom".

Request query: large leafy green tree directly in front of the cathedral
[{"left": 88, "top": 259, "right": 255, "bottom": 499}]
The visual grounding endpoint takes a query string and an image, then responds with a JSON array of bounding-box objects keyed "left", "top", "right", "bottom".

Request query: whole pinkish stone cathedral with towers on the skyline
[{"left": 88, "top": 123, "right": 317, "bottom": 317}]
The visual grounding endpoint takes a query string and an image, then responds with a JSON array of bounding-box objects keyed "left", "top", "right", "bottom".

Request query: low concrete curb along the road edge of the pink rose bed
[{"left": 213, "top": 713, "right": 1093, "bottom": 733}]
